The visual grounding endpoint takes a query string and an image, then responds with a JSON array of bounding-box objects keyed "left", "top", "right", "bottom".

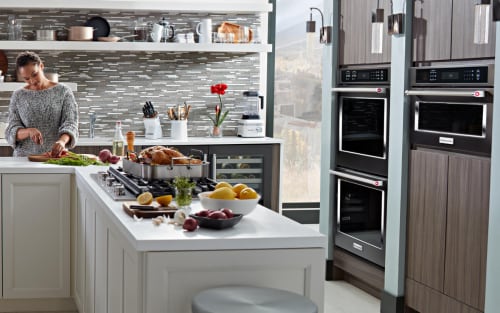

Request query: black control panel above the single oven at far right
[{"left": 411, "top": 65, "right": 493, "bottom": 86}]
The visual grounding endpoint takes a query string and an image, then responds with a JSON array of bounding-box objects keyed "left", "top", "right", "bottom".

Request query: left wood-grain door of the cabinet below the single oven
[{"left": 407, "top": 150, "right": 448, "bottom": 291}]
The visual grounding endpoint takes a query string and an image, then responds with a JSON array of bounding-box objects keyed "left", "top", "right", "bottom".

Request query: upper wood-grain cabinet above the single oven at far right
[{"left": 413, "top": 0, "right": 495, "bottom": 62}]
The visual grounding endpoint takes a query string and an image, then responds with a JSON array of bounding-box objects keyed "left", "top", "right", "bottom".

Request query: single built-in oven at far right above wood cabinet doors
[{"left": 407, "top": 65, "right": 493, "bottom": 156}]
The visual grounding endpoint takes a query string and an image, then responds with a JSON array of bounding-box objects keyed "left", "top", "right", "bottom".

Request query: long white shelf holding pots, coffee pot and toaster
[{"left": 0, "top": 40, "right": 272, "bottom": 53}]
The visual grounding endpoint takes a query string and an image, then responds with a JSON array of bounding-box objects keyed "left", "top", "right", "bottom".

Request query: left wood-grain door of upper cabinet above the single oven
[{"left": 413, "top": 0, "right": 454, "bottom": 62}]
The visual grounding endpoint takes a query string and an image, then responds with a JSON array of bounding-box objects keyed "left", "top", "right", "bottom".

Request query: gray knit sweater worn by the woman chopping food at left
[{"left": 5, "top": 84, "right": 78, "bottom": 156}]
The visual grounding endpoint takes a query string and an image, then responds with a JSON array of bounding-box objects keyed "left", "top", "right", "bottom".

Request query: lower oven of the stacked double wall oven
[{"left": 330, "top": 168, "right": 387, "bottom": 267}]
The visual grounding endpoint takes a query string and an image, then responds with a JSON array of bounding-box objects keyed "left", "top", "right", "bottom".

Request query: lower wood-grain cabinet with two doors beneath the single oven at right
[{"left": 406, "top": 150, "right": 490, "bottom": 313}]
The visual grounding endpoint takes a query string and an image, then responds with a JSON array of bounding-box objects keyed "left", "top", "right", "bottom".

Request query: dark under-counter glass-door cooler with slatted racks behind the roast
[{"left": 209, "top": 145, "right": 280, "bottom": 211}]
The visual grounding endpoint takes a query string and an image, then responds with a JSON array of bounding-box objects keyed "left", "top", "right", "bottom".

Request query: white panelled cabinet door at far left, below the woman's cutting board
[{"left": 2, "top": 174, "right": 71, "bottom": 299}]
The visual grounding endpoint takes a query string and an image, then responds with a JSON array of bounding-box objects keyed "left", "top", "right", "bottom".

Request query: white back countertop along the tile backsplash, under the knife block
[{"left": 0, "top": 136, "right": 283, "bottom": 146}]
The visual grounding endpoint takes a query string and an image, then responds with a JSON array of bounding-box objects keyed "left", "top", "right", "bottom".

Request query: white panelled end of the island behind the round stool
[{"left": 145, "top": 248, "right": 325, "bottom": 313}]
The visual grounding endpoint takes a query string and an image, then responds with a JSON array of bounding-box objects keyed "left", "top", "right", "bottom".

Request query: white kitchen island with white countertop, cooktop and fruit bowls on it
[{"left": 0, "top": 158, "right": 326, "bottom": 313}]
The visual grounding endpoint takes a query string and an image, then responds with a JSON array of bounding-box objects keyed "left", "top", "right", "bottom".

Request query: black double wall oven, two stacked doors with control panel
[{"left": 330, "top": 67, "right": 390, "bottom": 266}]
